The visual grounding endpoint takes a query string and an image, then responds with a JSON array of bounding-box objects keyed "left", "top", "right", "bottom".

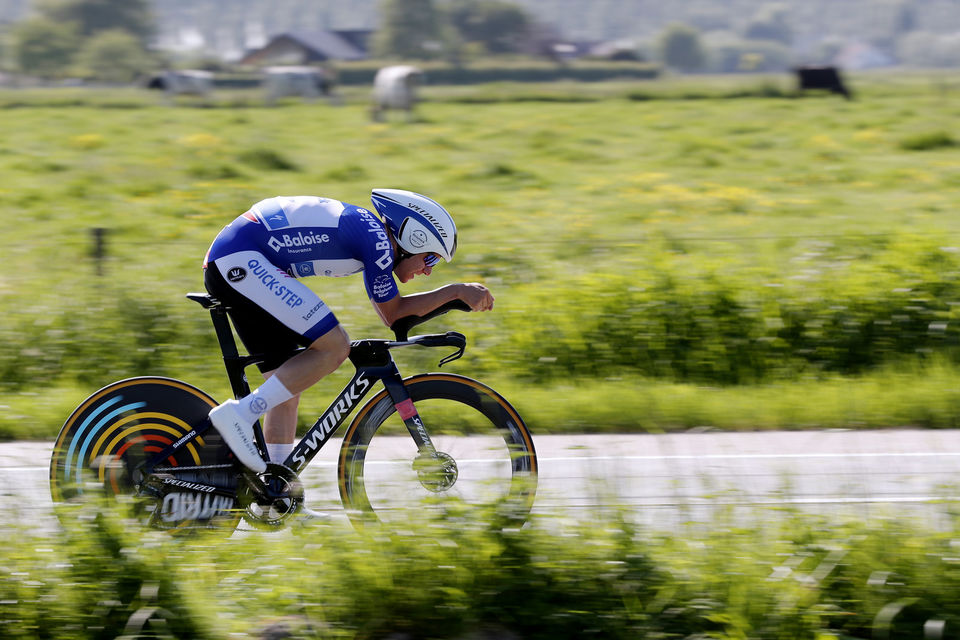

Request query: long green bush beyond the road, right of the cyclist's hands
[{"left": 498, "top": 239, "right": 960, "bottom": 384}]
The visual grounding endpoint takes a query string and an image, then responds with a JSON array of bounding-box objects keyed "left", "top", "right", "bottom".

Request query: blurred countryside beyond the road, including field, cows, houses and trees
[{"left": 0, "top": 0, "right": 960, "bottom": 438}]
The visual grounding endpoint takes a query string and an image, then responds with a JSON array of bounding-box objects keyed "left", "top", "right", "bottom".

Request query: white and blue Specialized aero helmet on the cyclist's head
[{"left": 370, "top": 189, "right": 457, "bottom": 262}]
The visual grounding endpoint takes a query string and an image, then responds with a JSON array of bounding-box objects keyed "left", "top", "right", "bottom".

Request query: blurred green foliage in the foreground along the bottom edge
[{"left": 0, "top": 506, "right": 960, "bottom": 640}]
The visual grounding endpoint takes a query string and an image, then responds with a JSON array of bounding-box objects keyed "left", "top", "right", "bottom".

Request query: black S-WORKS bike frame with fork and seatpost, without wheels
[{"left": 143, "top": 294, "right": 463, "bottom": 488}]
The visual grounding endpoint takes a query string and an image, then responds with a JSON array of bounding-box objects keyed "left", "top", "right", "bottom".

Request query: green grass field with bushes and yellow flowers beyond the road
[{"left": 0, "top": 71, "right": 960, "bottom": 437}]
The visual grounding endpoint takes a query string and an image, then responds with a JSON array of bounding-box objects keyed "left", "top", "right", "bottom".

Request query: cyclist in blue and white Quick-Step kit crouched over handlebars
[{"left": 203, "top": 189, "right": 493, "bottom": 473}]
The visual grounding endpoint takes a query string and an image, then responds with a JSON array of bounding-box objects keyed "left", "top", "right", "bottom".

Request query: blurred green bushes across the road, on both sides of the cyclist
[{"left": 15, "top": 243, "right": 960, "bottom": 389}]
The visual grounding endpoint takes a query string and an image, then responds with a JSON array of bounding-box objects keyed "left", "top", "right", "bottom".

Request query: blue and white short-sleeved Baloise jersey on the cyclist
[{"left": 204, "top": 196, "right": 399, "bottom": 302}]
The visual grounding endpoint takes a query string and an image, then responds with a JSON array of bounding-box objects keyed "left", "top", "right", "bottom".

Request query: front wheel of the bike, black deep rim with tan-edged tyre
[{"left": 339, "top": 374, "right": 537, "bottom": 523}]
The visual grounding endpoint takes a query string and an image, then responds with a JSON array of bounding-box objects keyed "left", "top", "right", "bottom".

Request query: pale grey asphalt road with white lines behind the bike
[{"left": 0, "top": 429, "right": 960, "bottom": 527}]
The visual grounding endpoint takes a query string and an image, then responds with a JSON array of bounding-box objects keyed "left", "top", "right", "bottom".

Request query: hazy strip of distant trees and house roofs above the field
[{"left": 0, "top": 0, "right": 960, "bottom": 76}]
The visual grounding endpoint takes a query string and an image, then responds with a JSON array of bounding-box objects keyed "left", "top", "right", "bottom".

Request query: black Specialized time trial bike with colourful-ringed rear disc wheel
[{"left": 50, "top": 293, "right": 537, "bottom": 532}]
